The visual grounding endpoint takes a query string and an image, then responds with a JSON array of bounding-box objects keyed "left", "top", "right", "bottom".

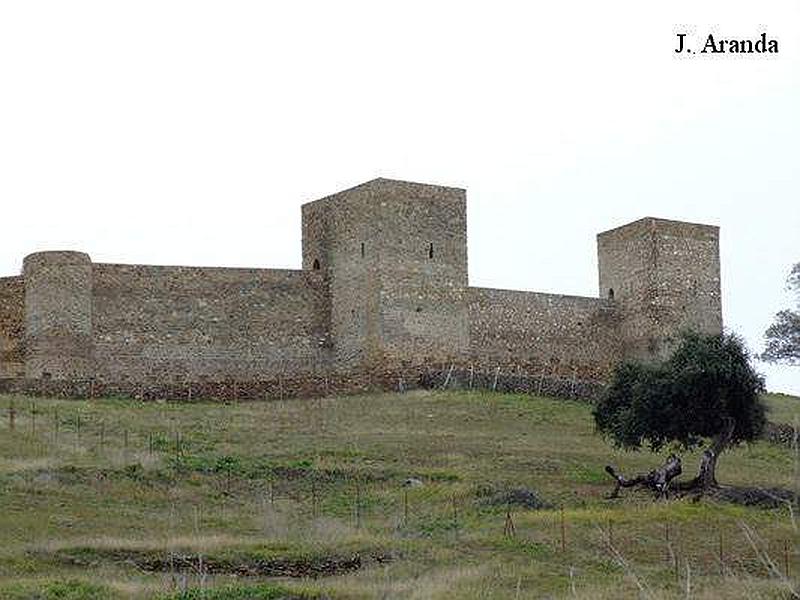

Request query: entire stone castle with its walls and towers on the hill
[{"left": 0, "top": 179, "right": 722, "bottom": 397}]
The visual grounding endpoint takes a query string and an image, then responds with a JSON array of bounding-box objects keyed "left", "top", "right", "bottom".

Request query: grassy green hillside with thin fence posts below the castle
[{"left": 0, "top": 392, "right": 800, "bottom": 600}]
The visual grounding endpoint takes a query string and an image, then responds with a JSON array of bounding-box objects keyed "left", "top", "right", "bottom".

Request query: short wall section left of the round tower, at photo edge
[{"left": 0, "top": 277, "right": 25, "bottom": 378}]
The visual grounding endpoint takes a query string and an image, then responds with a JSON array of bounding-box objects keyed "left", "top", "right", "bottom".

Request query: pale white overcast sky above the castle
[{"left": 0, "top": 0, "right": 800, "bottom": 393}]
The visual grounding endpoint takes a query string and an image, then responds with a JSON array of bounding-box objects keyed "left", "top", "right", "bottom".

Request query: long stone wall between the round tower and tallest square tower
[{"left": 92, "top": 264, "right": 327, "bottom": 382}]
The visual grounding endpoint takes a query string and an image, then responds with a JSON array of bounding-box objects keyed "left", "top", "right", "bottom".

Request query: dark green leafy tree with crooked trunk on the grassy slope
[{"left": 594, "top": 332, "right": 766, "bottom": 494}]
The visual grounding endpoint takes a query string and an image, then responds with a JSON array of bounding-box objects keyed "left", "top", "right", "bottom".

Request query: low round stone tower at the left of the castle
[{"left": 23, "top": 252, "right": 93, "bottom": 379}]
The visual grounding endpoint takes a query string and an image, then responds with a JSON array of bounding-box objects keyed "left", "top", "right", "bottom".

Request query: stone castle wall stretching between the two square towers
[{"left": 468, "top": 287, "right": 621, "bottom": 381}]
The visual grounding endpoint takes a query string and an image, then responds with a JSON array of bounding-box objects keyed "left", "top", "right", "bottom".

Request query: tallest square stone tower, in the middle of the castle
[{"left": 302, "top": 179, "right": 469, "bottom": 370}]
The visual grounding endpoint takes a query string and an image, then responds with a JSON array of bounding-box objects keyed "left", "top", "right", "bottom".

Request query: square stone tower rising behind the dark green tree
[{"left": 597, "top": 217, "right": 722, "bottom": 360}]
